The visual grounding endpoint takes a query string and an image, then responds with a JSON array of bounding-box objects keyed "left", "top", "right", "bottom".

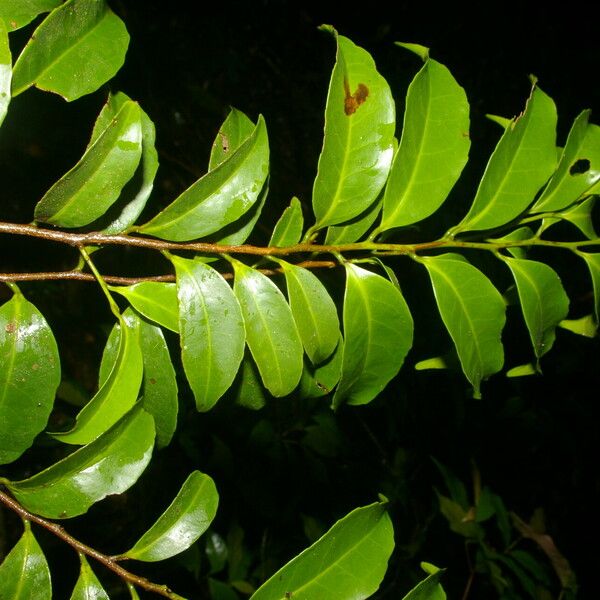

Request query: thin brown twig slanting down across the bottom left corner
[{"left": 0, "top": 491, "right": 183, "bottom": 600}]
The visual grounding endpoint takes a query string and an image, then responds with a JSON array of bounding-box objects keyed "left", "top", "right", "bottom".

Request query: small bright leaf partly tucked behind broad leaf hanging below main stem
[{"left": 109, "top": 281, "right": 179, "bottom": 333}]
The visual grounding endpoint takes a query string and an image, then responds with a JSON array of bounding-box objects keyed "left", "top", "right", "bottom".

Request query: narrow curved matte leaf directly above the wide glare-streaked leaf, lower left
[{"left": 50, "top": 311, "right": 143, "bottom": 444}]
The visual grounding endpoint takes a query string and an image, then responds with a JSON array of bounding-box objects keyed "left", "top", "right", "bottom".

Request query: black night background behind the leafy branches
[{"left": 0, "top": 0, "right": 600, "bottom": 598}]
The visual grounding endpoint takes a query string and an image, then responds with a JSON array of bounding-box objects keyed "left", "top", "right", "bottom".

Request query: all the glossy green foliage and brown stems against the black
[{"left": 0, "top": 0, "right": 600, "bottom": 599}]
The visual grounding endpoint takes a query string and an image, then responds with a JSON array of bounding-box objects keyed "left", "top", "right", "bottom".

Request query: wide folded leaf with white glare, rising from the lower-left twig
[{"left": 6, "top": 403, "right": 154, "bottom": 519}]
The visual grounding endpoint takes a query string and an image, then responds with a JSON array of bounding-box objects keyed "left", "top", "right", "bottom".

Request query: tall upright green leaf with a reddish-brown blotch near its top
[{"left": 313, "top": 28, "right": 395, "bottom": 229}]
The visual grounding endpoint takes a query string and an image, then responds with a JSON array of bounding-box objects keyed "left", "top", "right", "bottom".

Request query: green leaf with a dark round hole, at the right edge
[{"left": 532, "top": 110, "right": 600, "bottom": 212}]
